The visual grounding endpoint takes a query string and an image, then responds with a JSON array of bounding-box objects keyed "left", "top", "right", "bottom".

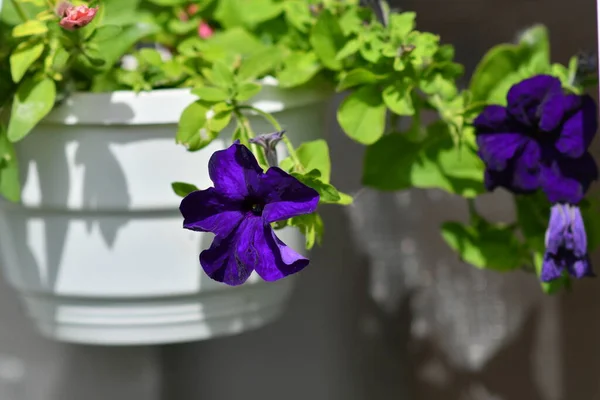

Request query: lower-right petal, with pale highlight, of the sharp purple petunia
[{"left": 256, "top": 225, "right": 309, "bottom": 281}]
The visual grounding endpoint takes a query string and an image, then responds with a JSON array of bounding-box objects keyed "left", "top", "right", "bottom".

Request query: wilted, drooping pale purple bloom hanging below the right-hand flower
[{"left": 541, "top": 204, "right": 594, "bottom": 282}]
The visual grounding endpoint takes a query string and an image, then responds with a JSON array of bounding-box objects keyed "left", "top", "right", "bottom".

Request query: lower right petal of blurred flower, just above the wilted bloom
[{"left": 540, "top": 153, "right": 598, "bottom": 204}]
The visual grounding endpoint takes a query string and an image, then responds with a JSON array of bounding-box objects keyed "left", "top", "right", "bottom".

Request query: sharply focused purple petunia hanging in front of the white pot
[{"left": 179, "top": 142, "right": 319, "bottom": 286}]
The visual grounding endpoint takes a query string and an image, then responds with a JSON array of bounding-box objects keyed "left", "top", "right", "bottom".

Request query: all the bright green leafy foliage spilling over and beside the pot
[{"left": 0, "top": 0, "right": 600, "bottom": 292}]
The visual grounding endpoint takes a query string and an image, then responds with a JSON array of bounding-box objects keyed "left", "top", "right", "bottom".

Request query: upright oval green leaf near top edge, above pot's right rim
[{"left": 310, "top": 10, "right": 345, "bottom": 70}]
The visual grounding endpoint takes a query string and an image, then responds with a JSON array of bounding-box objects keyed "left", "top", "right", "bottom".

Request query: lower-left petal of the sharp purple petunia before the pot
[{"left": 200, "top": 217, "right": 264, "bottom": 286}]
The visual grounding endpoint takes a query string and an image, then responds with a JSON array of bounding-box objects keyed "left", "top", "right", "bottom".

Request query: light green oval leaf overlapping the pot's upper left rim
[{"left": 7, "top": 78, "right": 56, "bottom": 143}]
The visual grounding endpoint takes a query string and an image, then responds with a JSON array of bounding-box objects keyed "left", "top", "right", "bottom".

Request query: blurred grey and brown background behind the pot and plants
[{"left": 0, "top": 0, "right": 600, "bottom": 400}]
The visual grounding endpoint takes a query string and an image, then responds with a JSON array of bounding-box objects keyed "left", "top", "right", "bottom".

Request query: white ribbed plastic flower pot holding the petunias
[{"left": 0, "top": 80, "right": 328, "bottom": 345}]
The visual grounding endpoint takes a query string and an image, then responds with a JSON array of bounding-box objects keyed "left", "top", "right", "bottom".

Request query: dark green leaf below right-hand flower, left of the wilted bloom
[{"left": 442, "top": 220, "right": 527, "bottom": 272}]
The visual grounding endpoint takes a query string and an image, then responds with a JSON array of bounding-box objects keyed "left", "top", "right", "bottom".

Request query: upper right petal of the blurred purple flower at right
[{"left": 556, "top": 95, "right": 598, "bottom": 158}]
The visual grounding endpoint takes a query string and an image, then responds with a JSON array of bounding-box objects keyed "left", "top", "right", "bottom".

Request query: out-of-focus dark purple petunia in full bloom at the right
[{"left": 474, "top": 75, "right": 598, "bottom": 203}]
